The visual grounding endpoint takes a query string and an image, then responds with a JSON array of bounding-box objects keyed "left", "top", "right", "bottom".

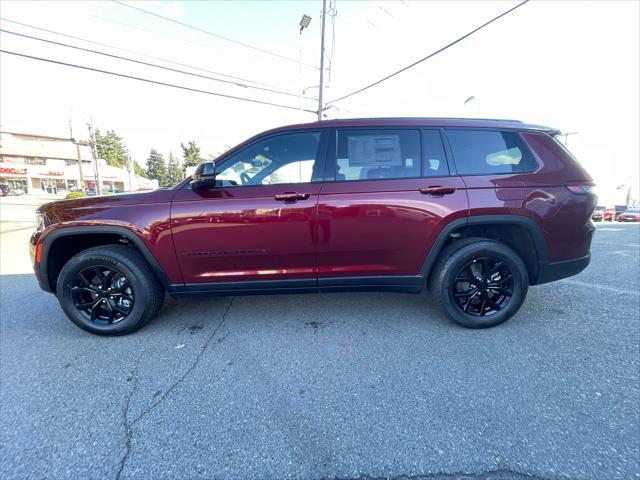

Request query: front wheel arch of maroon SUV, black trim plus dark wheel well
[{"left": 40, "top": 225, "right": 171, "bottom": 293}]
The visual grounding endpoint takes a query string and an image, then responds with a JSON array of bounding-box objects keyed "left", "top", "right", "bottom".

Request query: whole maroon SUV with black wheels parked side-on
[{"left": 31, "top": 118, "right": 596, "bottom": 335}]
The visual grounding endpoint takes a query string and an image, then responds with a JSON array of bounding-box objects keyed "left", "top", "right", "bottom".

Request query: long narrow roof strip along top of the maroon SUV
[{"left": 262, "top": 117, "right": 560, "bottom": 135}]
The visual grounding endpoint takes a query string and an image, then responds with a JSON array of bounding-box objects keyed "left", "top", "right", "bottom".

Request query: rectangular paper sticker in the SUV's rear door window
[{"left": 348, "top": 135, "right": 402, "bottom": 167}]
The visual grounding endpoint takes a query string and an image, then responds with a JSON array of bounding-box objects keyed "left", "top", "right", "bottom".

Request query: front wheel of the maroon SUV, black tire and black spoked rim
[{"left": 56, "top": 245, "right": 165, "bottom": 336}]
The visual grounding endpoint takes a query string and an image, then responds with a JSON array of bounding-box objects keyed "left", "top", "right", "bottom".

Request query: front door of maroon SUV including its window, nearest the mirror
[{"left": 171, "top": 131, "right": 326, "bottom": 289}]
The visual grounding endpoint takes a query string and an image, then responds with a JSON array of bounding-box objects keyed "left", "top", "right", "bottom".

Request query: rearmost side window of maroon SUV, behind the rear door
[{"left": 447, "top": 129, "right": 536, "bottom": 175}]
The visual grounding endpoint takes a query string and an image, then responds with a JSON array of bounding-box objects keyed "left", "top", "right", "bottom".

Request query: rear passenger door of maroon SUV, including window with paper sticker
[{"left": 318, "top": 128, "right": 468, "bottom": 286}]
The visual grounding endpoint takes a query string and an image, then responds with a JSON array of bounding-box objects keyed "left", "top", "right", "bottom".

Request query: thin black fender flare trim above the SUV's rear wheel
[{"left": 420, "top": 215, "right": 548, "bottom": 280}]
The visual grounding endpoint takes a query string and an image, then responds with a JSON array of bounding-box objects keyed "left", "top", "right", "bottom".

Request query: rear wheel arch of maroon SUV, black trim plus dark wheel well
[{"left": 420, "top": 215, "right": 547, "bottom": 285}]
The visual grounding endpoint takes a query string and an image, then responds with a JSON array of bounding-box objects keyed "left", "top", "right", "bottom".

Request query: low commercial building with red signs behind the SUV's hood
[{"left": 0, "top": 131, "right": 158, "bottom": 194}]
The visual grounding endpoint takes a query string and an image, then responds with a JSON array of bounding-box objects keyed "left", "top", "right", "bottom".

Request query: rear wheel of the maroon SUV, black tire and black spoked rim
[{"left": 429, "top": 238, "right": 529, "bottom": 328}]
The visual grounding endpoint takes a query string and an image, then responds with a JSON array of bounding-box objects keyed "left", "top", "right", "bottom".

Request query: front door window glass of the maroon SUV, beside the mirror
[{"left": 216, "top": 132, "right": 320, "bottom": 187}]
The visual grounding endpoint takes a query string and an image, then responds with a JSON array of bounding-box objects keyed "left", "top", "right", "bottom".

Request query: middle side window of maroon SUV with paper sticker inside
[{"left": 336, "top": 129, "right": 420, "bottom": 181}]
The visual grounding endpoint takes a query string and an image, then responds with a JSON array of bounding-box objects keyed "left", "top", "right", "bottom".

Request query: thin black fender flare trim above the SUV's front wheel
[{"left": 40, "top": 225, "right": 175, "bottom": 289}]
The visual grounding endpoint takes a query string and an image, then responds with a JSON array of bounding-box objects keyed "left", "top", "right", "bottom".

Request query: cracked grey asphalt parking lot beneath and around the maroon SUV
[{"left": 0, "top": 199, "right": 640, "bottom": 480}]
